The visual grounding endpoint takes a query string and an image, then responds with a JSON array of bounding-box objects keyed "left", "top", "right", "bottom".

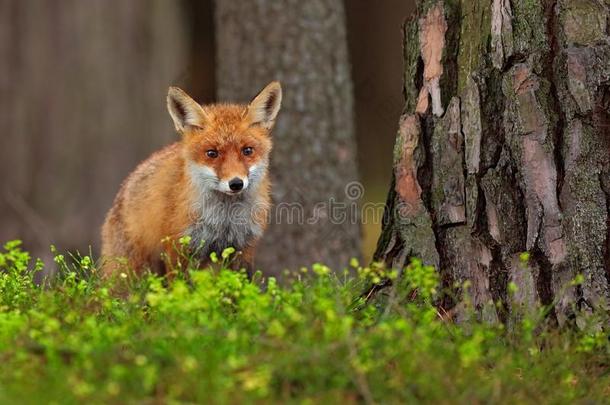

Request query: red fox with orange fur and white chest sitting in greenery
[{"left": 102, "top": 82, "right": 282, "bottom": 275}]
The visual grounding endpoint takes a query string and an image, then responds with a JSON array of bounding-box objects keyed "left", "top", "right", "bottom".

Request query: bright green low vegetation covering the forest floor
[{"left": 0, "top": 238, "right": 610, "bottom": 403}]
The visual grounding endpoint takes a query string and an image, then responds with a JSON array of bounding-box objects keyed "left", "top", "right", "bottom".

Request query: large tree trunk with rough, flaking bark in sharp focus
[{"left": 375, "top": 0, "right": 610, "bottom": 324}]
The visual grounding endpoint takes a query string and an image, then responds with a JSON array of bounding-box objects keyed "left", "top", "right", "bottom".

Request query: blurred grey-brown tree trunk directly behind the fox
[{"left": 215, "top": 0, "right": 361, "bottom": 274}]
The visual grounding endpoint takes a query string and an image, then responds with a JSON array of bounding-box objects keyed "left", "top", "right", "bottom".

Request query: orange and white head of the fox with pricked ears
[{"left": 167, "top": 82, "right": 282, "bottom": 195}]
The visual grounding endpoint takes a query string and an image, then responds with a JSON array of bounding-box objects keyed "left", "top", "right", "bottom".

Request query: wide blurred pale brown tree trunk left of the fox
[{"left": 0, "top": 0, "right": 187, "bottom": 262}]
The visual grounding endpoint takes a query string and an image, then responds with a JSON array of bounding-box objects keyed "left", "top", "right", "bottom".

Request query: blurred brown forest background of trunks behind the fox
[{"left": 0, "top": 0, "right": 414, "bottom": 267}]
